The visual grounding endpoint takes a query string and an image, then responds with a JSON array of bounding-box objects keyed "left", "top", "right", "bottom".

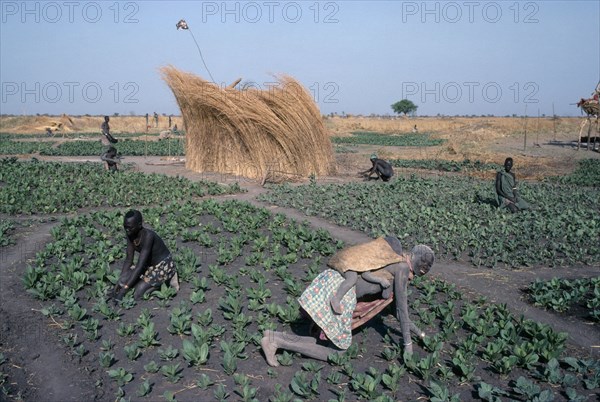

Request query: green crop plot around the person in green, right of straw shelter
[{"left": 260, "top": 168, "right": 600, "bottom": 267}]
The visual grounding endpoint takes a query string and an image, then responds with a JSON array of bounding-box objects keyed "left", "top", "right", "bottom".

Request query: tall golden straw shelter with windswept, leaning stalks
[{"left": 161, "top": 66, "right": 334, "bottom": 181}]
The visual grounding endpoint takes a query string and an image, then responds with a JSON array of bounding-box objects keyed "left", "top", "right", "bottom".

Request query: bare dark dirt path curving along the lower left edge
[{"left": 0, "top": 222, "right": 101, "bottom": 402}]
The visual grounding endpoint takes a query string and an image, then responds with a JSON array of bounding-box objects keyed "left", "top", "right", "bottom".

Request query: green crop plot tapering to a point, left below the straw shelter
[{"left": 0, "top": 158, "right": 241, "bottom": 214}]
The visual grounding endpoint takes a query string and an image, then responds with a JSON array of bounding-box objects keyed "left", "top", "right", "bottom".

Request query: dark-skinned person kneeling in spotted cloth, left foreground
[{"left": 114, "top": 209, "right": 179, "bottom": 300}]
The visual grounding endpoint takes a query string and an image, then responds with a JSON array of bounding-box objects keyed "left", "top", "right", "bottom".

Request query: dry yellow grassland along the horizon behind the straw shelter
[{"left": 0, "top": 115, "right": 600, "bottom": 180}]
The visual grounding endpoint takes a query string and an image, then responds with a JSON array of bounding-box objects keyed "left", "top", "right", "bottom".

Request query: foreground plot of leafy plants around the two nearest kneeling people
[{"left": 23, "top": 200, "right": 600, "bottom": 401}]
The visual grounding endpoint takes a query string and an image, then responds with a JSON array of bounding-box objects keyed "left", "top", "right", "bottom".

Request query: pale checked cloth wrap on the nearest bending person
[{"left": 298, "top": 269, "right": 356, "bottom": 349}]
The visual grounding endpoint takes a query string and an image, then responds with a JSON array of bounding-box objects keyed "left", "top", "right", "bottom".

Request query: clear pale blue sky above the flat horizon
[{"left": 0, "top": 0, "right": 600, "bottom": 116}]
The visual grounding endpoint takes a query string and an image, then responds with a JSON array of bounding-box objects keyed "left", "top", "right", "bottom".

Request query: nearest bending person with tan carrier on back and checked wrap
[{"left": 261, "top": 237, "right": 435, "bottom": 366}]
